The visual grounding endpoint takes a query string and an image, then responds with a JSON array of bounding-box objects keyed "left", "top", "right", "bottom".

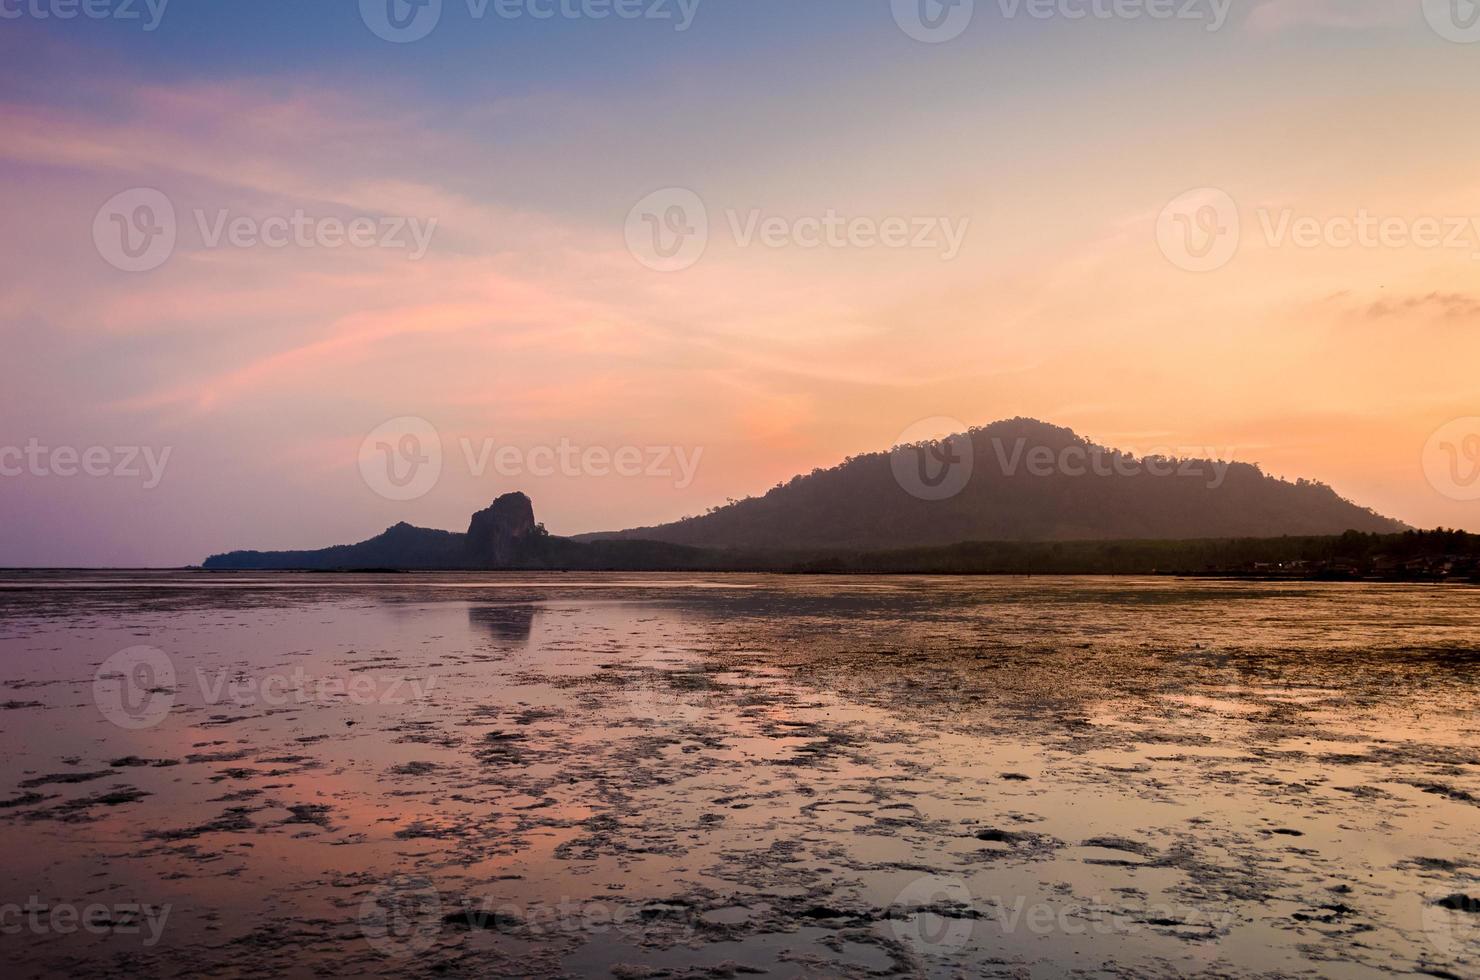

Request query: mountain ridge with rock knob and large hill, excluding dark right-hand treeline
[{"left": 204, "top": 419, "right": 1409, "bottom": 570}]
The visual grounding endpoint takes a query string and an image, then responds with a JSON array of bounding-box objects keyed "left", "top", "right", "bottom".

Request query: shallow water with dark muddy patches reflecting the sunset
[{"left": 0, "top": 573, "right": 1480, "bottom": 977}]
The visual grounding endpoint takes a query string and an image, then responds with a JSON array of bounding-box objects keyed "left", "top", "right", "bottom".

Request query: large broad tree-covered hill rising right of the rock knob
[{"left": 577, "top": 419, "right": 1406, "bottom": 551}]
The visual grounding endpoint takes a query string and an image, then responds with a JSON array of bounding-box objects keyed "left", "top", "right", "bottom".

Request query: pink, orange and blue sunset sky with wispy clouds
[{"left": 0, "top": 0, "right": 1480, "bottom": 565}]
